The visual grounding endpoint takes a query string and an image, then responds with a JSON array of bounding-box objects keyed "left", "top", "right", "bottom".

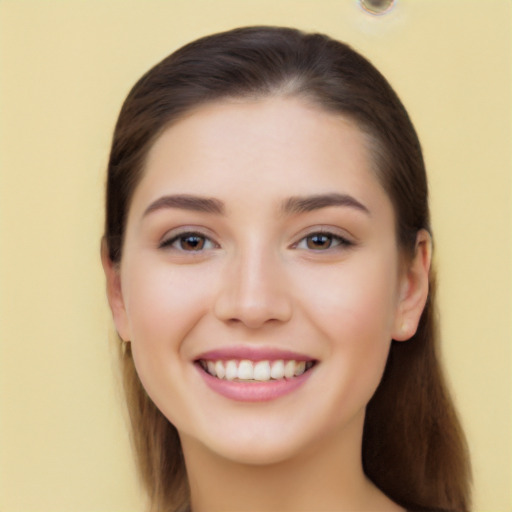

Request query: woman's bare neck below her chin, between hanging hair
[{"left": 181, "top": 414, "right": 401, "bottom": 512}]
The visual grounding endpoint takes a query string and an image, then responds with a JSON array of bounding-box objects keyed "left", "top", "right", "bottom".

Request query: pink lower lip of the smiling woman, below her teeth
[{"left": 197, "top": 365, "right": 312, "bottom": 402}]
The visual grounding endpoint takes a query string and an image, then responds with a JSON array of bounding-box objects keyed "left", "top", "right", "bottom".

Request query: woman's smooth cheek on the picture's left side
[{"left": 123, "top": 258, "right": 220, "bottom": 424}]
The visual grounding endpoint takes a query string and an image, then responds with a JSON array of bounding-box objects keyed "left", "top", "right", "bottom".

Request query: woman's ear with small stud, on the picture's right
[{"left": 392, "top": 229, "right": 432, "bottom": 341}]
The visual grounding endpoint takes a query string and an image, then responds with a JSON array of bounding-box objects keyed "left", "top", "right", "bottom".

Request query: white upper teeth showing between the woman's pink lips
[{"left": 200, "top": 359, "right": 313, "bottom": 381}]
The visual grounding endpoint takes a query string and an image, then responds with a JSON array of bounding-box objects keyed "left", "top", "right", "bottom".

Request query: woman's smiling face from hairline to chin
[{"left": 105, "top": 98, "right": 424, "bottom": 463}]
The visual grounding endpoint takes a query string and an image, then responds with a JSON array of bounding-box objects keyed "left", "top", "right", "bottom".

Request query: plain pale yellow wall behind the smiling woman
[{"left": 0, "top": 0, "right": 512, "bottom": 512}]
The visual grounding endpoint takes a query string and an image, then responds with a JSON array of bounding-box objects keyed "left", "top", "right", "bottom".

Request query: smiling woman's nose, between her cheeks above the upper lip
[{"left": 214, "top": 245, "right": 292, "bottom": 329}]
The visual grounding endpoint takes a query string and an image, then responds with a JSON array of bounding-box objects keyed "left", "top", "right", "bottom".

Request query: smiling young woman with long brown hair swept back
[{"left": 102, "top": 27, "right": 469, "bottom": 512}]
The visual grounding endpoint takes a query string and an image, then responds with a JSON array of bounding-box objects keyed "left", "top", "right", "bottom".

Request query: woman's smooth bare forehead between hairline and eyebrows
[{"left": 130, "top": 97, "right": 387, "bottom": 219}]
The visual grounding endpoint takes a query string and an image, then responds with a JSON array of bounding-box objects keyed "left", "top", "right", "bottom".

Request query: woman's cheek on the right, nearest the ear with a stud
[{"left": 294, "top": 261, "right": 396, "bottom": 404}]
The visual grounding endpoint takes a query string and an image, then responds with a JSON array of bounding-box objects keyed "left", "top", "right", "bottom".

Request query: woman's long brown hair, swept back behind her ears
[{"left": 104, "top": 27, "right": 470, "bottom": 512}]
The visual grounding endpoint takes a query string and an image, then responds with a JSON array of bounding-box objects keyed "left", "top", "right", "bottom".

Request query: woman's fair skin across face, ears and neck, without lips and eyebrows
[{"left": 103, "top": 97, "right": 430, "bottom": 512}]
